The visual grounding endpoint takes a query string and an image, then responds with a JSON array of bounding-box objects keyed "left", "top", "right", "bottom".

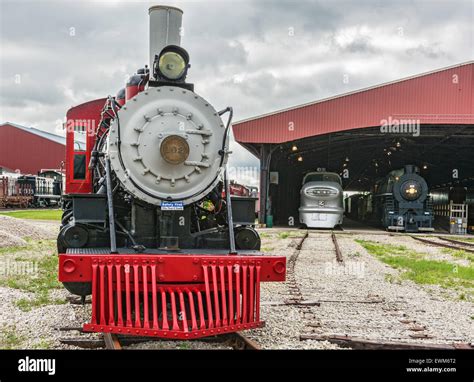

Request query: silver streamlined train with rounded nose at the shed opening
[{"left": 299, "top": 172, "right": 344, "bottom": 228}]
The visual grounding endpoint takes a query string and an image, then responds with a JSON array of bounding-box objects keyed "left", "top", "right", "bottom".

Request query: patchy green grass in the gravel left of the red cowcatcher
[{"left": 0, "top": 240, "right": 66, "bottom": 311}]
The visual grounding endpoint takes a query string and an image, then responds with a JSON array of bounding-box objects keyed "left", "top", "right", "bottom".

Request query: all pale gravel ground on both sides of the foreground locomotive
[{"left": 0, "top": 216, "right": 474, "bottom": 350}]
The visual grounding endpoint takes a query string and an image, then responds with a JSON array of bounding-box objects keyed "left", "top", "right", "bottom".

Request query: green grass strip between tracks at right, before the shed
[{"left": 356, "top": 240, "right": 474, "bottom": 300}]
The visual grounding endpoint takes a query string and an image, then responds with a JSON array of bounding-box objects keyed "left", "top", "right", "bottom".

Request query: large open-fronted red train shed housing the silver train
[{"left": 233, "top": 61, "right": 474, "bottom": 225}]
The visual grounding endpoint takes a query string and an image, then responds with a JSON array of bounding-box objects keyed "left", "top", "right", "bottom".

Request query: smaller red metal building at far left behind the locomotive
[{"left": 0, "top": 122, "right": 66, "bottom": 174}]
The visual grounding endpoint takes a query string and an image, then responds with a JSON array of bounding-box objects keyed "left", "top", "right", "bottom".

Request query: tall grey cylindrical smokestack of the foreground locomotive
[{"left": 148, "top": 5, "right": 183, "bottom": 79}]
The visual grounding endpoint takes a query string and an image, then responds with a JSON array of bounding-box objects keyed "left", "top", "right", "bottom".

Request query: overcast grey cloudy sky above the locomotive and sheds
[{"left": 0, "top": 0, "right": 474, "bottom": 185}]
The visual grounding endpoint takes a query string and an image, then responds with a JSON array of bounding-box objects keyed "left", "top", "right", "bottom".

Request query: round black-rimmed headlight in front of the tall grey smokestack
[{"left": 156, "top": 45, "right": 189, "bottom": 81}]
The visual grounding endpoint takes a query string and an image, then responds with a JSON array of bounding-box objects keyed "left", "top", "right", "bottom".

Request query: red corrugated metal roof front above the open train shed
[{"left": 233, "top": 61, "right": 474, "bottom": 143}]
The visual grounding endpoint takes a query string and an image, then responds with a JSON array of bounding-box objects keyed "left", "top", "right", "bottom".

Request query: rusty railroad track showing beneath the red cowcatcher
[{"left": 59, "top": 327, "right": 261, "bottom": 350}]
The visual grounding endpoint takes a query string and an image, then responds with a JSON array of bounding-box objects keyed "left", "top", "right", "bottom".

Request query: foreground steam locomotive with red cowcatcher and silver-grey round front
[{"left": 58, "top": 6, "right": 286, "bottom": 339}]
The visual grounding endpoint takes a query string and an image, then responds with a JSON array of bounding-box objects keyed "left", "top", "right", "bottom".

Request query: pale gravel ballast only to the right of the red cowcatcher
[{"left": 246, "top": 231, "right": 474, "bottom": 349}]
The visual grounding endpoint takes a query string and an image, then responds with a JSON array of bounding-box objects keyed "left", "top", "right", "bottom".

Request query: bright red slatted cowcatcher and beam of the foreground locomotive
[{"left": 60, "top": 255, "right": 286, "bottom": 339}]
